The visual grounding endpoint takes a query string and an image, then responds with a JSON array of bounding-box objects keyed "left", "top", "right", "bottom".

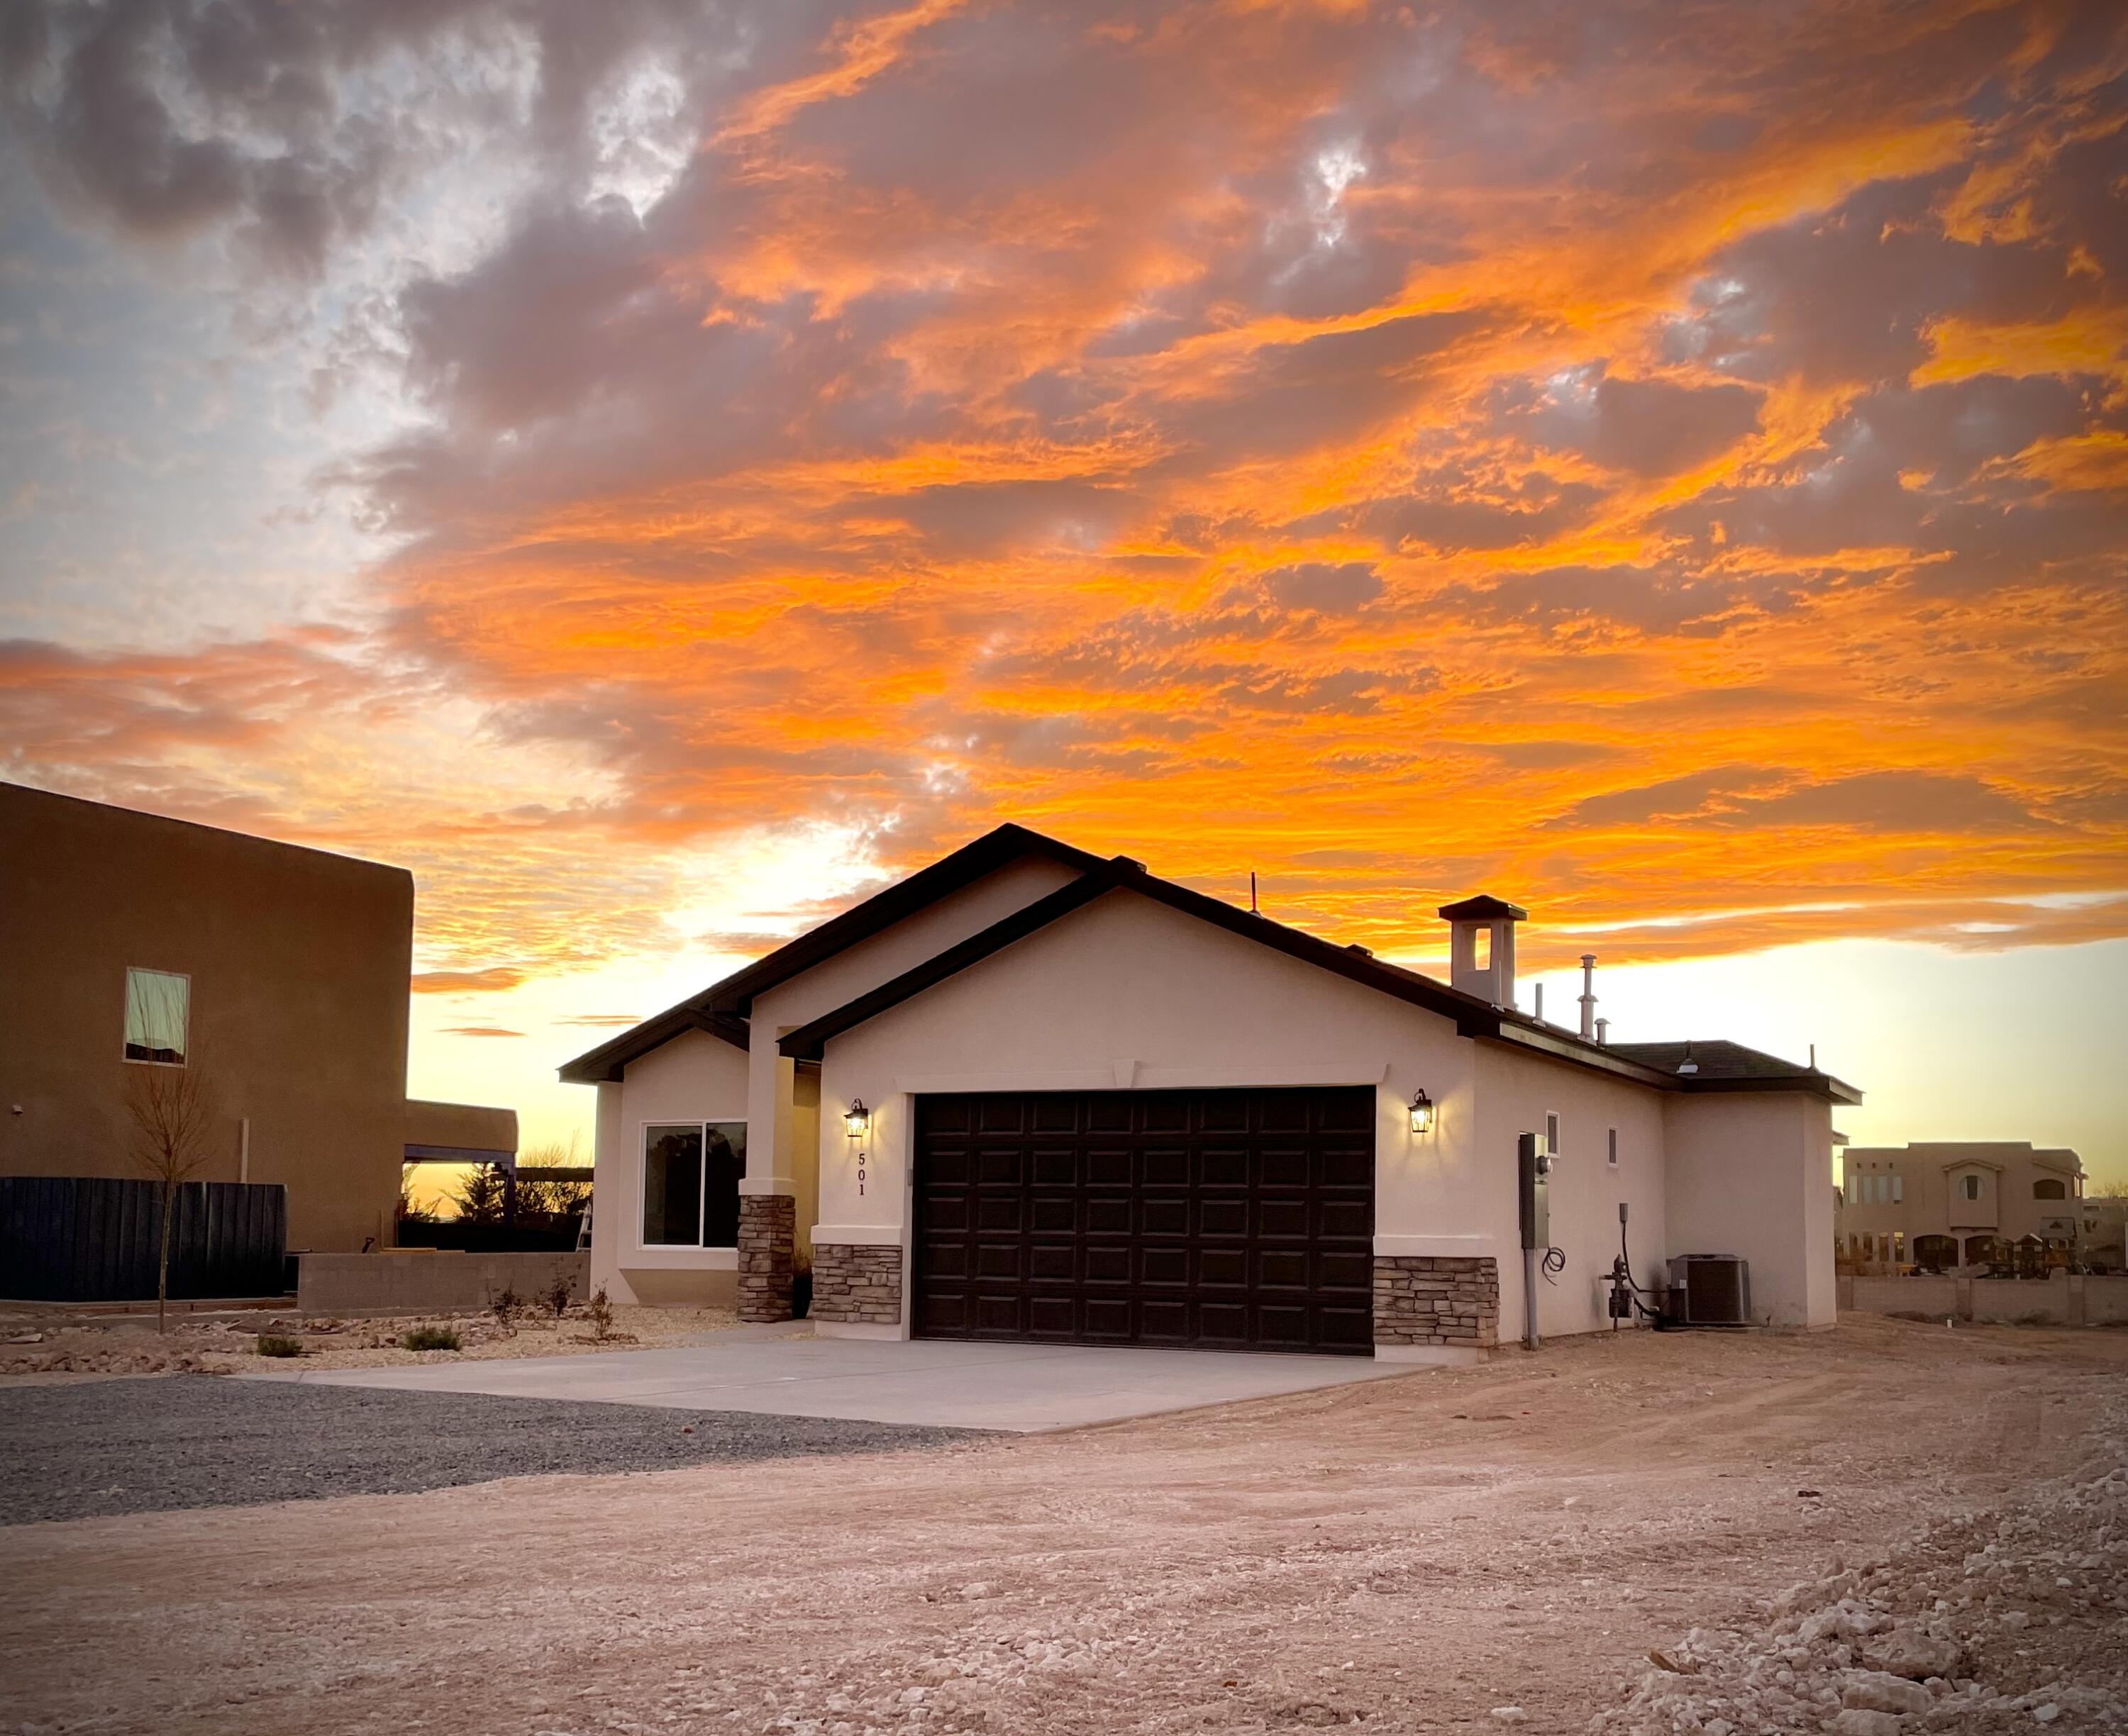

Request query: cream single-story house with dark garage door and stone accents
[{"left": 562, "top": 825, "right": 1858, "bottom": 1362}]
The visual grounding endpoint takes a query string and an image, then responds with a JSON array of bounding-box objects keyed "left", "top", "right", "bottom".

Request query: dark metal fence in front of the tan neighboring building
[{"left": 0, "top": 1176, "right": 287, "bottom": 1302}]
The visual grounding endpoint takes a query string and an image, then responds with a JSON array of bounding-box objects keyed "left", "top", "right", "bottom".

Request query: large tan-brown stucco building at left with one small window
[{"left": 0, "top": 783, "right": 517, "bottom": 1259}]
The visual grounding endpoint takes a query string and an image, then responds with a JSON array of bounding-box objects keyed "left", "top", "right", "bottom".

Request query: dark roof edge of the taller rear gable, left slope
[{"left": 560, "top": 823, "right": 1102, "bottom": 1085}]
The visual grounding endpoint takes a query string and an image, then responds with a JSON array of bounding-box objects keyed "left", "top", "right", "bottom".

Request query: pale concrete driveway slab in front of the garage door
[{"left": 240, "top": 1332, "right": 1413, "bottom": 1434}]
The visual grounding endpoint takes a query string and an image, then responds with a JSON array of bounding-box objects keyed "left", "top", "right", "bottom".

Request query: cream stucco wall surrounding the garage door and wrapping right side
[{"left": 815, "top": 891, "right": 1664, "bottom": 1338}]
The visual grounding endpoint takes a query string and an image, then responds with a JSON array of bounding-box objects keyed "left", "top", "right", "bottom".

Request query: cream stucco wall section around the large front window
[{"left": 592, "top": 1032, "right": 753, "bottom": 1302}]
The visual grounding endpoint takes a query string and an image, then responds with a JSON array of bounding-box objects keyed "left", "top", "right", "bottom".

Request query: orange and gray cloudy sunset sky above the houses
[{"left": 0, "top": 0, "right": 2128, "bottom": 1176}]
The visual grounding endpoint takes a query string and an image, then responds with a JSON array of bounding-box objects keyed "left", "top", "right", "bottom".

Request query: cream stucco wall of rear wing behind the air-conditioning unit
[{"left": 1664, "top": 1091, "right": 1839, "bottom": 1328}]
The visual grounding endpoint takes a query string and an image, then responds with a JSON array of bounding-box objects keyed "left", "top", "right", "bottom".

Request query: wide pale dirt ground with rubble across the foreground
[{"left": 0, "top": 1317, "right": 2128, "bottom": 1736}]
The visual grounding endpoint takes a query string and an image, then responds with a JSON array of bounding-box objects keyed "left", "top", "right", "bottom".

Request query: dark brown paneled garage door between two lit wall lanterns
[{"left": 913, "top": 1087, "right": 1375, "bottom": 1355}]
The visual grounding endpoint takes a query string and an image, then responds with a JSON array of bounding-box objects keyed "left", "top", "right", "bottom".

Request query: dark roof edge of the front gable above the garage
[{"left": 777, "top": 855, "right": 1862, "bottom": 1102}]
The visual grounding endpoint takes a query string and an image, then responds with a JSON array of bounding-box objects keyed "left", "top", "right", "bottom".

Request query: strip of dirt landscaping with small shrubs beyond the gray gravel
[{"left": 0, "top": 1304, "right": 738, "bottom": 1383}]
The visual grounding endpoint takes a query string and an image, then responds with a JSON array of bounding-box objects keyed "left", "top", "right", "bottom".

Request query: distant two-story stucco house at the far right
[{"left": 1834, "top": 1140, "right": 2083, "bottom": 1272}]
